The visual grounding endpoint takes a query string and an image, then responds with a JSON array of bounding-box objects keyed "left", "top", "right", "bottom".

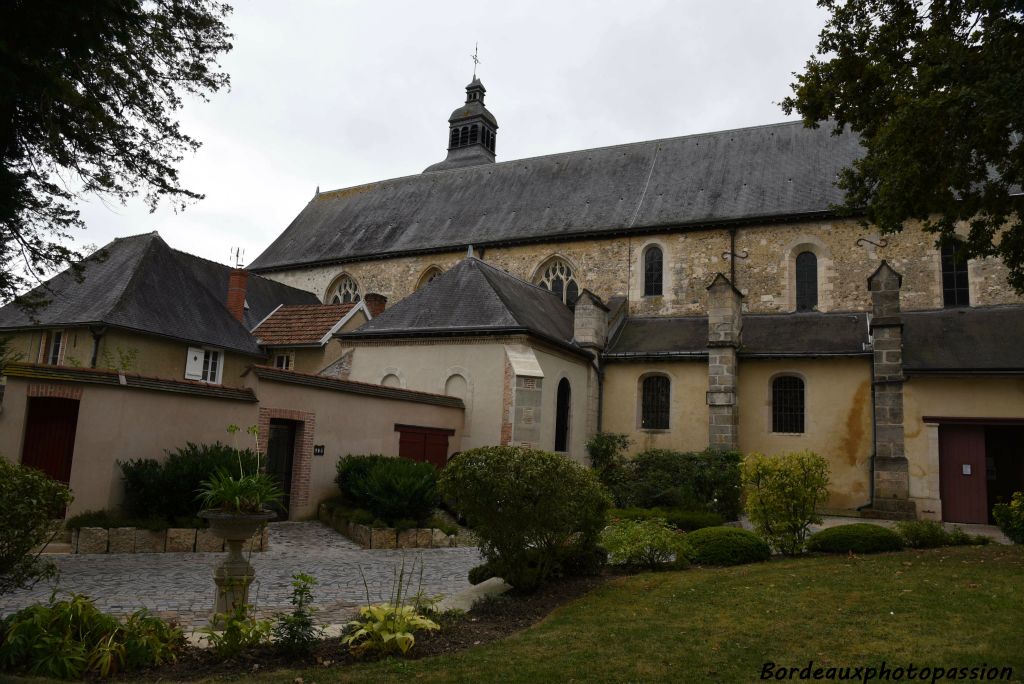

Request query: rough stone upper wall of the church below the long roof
[{"left": 260, "top": 219, "right": 1024, "bottom": 315}]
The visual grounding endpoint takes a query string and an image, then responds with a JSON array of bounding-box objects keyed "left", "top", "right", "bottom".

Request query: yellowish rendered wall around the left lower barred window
[{"left": 601, "top": 359, "right": 708, "bottom": 454}]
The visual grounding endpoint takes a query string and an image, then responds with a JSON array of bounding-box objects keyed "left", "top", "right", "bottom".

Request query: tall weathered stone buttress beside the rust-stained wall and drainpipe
[{"left": 867, "top": 261, "right": 915, "bottom": 518}]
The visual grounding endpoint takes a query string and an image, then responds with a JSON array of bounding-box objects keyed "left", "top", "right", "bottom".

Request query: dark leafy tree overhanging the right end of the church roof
[{"left": 781, "top": 0, "right": 1024, "bottom": 294}]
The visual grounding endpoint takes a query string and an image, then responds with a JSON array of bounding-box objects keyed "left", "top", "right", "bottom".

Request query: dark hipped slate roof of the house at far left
[{"left": 0, "top": 232, "right": 318, "bottom": 355}]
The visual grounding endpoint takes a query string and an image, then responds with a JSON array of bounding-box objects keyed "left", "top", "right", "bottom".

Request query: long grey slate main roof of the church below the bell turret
[{"left": 250, "top": 122, "right": 862, "bottom": 269}]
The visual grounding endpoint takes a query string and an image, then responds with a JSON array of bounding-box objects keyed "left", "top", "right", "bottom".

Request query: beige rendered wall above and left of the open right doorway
[{"left": 903, "top": 377, "right": 1024, "bottom": 520}]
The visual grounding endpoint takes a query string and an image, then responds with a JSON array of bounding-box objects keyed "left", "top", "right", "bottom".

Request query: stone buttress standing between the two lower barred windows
[{"left": 708, "top": 273, "right": 742, "bottom": 451}]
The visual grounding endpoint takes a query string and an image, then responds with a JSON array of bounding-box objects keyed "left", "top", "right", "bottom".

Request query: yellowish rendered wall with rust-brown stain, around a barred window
[{"left": 738, "top": 358, "right": 873, "bottom": 509}]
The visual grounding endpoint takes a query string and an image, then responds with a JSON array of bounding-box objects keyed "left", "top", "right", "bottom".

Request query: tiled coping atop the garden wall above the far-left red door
[{"left": 3, "top": 364, "right": 256, "bottom": 401}]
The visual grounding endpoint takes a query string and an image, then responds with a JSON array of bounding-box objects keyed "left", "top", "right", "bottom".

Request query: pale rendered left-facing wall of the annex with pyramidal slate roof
[{"left": 348, "top": 339, "right": 505, "bottom": 450}]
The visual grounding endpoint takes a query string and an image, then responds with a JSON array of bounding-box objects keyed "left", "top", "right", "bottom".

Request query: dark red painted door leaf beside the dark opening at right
[{"left": 939, "top": 425, "right": 988, "bottom": 524}]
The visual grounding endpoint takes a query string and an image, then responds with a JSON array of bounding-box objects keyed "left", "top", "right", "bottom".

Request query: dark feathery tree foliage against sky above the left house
[{"left": 0, "top": 0, "right": 231, "bottom": 304}]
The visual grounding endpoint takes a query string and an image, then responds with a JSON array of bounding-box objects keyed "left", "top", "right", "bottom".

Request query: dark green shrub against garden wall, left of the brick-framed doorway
[{"left": 118, "top": 441, "right": 257, "bottom": 526}]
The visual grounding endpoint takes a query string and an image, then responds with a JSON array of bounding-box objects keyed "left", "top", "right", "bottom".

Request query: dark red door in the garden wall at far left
[{"left": 22, "top": 396, "right": 78, "bottom": 484}]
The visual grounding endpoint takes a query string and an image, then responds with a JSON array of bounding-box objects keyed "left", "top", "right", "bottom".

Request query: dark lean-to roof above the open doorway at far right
[{"left": 903, "top": 306, "right": 1024, "bottom": 375}]
